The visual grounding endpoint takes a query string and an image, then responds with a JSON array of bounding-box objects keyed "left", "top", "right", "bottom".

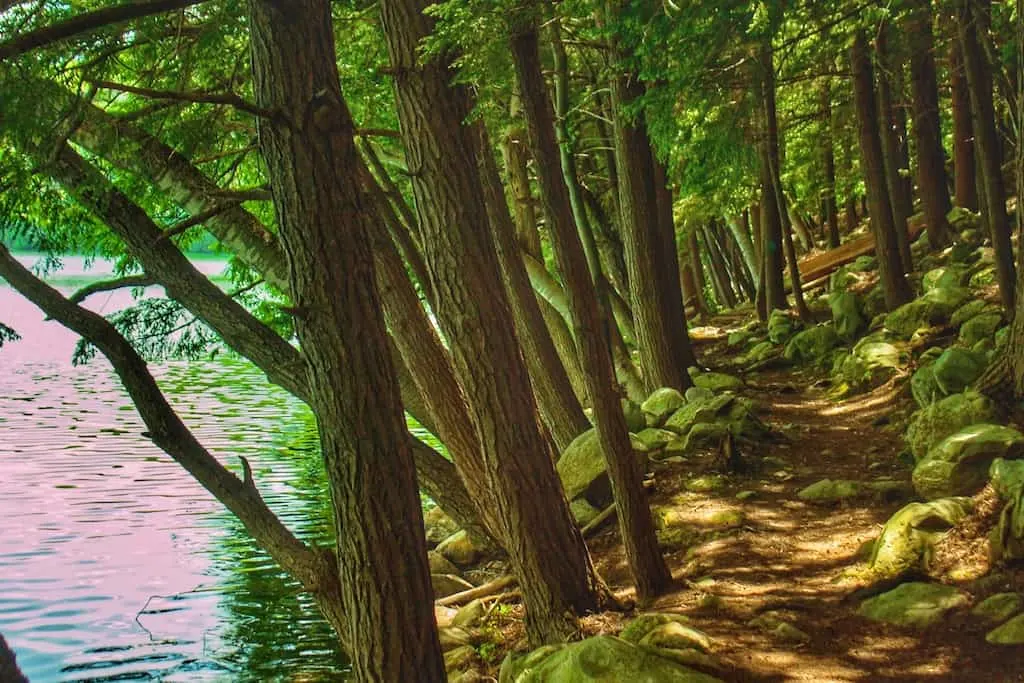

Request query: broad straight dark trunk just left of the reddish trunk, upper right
[{"left": 906, "top": 0, "right": 950, "bottom": 249}]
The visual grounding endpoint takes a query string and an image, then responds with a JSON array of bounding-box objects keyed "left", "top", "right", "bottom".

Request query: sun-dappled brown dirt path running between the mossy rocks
[{"left": 483, "top": 311, "right": 1024, "bottom": 682}]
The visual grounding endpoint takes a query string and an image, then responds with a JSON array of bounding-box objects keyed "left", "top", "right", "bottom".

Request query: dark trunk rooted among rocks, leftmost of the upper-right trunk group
[{"left": 850, "top": 32, "right": 913, "bottom": 310}]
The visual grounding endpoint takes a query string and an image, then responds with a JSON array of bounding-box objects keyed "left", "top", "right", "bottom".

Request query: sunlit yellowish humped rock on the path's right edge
[{"left": 868, "top": 498, "right": 972, "bottom": 579}]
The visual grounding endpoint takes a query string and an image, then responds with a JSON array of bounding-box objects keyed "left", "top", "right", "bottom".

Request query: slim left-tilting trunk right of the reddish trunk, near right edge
[{"left": 956, "top": 0, "right": 1017, "bottom": 311}]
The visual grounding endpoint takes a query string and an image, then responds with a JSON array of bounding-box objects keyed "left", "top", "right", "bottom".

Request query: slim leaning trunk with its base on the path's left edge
[{"left": 511, "top": 23, "right": 682, "bottom": 602}]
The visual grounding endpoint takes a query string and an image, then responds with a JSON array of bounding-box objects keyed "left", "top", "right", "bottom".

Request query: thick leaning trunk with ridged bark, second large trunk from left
[{"left": 381, "top": 0, "right": 606, "bottom": 647}]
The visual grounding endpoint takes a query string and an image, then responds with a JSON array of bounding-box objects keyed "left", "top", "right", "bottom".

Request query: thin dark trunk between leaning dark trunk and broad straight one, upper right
[{"left": 874, "top": 23, "right": 913, "bottom": 272}]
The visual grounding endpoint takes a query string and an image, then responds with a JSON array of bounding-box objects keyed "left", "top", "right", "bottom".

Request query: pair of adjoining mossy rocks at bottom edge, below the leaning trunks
[{"left": 498, "top": 613, "right": 721, "bottom": 683}]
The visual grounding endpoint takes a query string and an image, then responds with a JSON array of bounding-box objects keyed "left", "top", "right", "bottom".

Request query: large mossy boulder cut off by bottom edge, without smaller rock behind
[{"left": 498, "top": 636, "right": 720, "bottom": 683}]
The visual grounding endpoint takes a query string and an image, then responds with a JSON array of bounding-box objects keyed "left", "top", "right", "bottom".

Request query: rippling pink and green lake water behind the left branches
[{"left": 0, "top": 255, "right": 346, "bottom": 683}]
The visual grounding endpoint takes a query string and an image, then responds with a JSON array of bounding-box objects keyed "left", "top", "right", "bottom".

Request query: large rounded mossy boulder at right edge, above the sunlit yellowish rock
[{"left": 912, "top": 424, "right": 1024, "bottom": 501}]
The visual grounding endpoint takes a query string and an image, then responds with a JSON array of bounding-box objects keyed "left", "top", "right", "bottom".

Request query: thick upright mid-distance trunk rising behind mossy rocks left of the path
[{"left": 611, "top": 64, "right": 691, "bottom": 393}]
